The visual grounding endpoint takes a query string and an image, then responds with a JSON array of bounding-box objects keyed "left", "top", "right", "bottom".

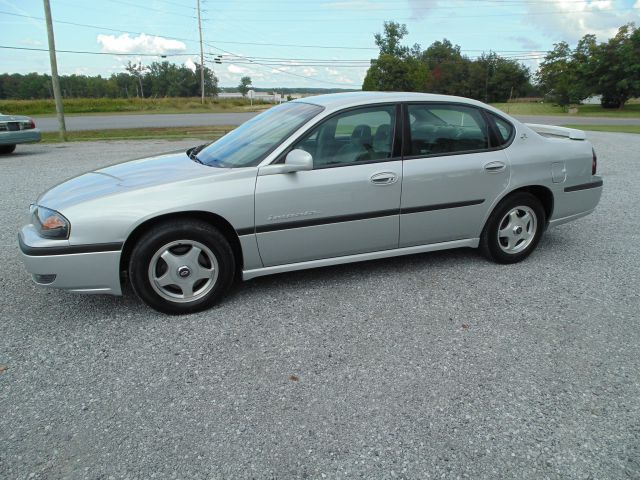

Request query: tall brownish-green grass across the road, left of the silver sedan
[{"left": 0, "top": 97, "right": 271, "bottom": 115}]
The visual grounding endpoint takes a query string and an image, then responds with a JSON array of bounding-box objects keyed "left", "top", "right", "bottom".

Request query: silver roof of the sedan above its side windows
[{"left": 294, "top": 92, "right": 511, "bottom": 118}]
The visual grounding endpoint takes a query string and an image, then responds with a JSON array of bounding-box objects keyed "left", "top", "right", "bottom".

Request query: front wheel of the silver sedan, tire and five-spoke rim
[{"left": 129, "top": 220, "right": 235, "bottom": 315}]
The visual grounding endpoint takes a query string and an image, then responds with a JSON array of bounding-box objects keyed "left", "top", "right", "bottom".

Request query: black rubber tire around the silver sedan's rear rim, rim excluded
[{"left": 480, "top": 192, "right": 547, "bottom": 263}]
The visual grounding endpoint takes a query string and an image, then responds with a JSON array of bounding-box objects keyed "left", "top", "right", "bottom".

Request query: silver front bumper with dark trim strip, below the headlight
[{"left": 18, "top": 225, "right": 122, "bottom": 295}]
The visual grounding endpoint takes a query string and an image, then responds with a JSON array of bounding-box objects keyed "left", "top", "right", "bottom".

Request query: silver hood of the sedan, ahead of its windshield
[{"left": 36, "top": 152, "right": 228, "bottom": 211}]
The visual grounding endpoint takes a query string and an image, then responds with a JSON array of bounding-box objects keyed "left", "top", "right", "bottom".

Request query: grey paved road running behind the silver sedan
[{"left": 35, "top": 112, "right": 640, "bottom": 132}]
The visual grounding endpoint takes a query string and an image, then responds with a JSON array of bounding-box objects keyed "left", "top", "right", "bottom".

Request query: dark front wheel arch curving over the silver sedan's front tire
[{"left": 120, "top": 210, "right": 244, "bottom": 272}]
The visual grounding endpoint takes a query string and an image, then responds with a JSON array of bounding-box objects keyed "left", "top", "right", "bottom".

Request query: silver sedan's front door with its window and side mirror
[{"left": 255, "top": 104, "right": 402, "bottom": 267}]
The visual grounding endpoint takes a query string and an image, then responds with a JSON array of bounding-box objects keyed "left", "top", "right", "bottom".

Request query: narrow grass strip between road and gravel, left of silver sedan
[{"left": 42, "top": 125, "right": 235, "bottom": 143}]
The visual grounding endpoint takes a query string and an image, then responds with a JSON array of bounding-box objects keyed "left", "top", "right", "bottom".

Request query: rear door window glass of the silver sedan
[{"left": 406, "top": 104, "right": 489, "bottom": 156}]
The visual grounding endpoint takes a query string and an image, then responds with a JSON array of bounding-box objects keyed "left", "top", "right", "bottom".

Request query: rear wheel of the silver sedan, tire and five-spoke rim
[{"left": 479, "top": 192, "right": 547, "bottom": 264}]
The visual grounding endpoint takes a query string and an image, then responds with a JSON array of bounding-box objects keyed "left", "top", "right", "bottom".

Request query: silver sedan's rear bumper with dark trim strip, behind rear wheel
[{"left": 549, "top": 175, "right": 603, "bottom": 226}]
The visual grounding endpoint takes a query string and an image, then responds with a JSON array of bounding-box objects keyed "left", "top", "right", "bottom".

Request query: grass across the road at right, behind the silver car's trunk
[{"left": 492, "top": 101, "right": 640, "bottom": 118}]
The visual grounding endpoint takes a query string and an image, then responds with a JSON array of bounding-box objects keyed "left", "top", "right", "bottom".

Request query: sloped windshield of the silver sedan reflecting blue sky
[{"left": 197, "top": 102, "right": 323, "bottom": 168}]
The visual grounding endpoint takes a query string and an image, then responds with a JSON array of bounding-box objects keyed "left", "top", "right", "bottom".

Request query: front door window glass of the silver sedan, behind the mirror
[{"left": 295, "top": 105, "right": 396, "bottom": 168}]
